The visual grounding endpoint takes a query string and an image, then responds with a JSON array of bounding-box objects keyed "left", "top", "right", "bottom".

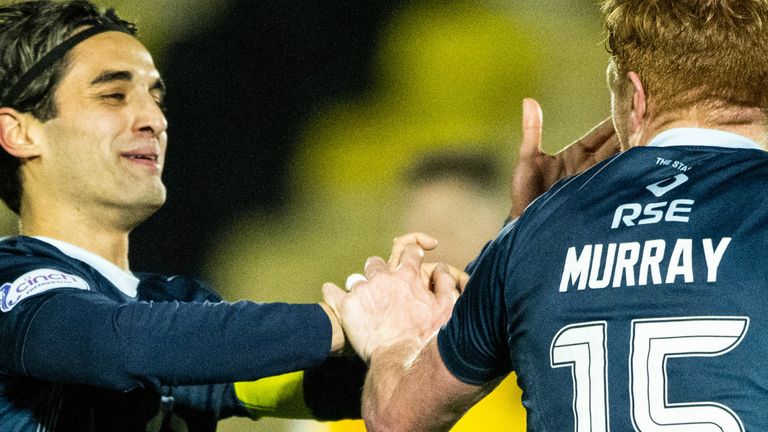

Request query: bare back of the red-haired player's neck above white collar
[{"left": 629, "top": 108, "right": 768, "bottom": 150}]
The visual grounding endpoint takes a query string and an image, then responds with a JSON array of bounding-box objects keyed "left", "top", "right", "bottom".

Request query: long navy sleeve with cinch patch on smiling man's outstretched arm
[{"left": 0, "top": 263, "right": 331, "bottom": 391}]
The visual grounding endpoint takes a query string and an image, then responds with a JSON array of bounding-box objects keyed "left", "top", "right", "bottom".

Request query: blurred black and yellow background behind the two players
[{"left": 1, "top": 0, "right": 609, "bottom": 431}]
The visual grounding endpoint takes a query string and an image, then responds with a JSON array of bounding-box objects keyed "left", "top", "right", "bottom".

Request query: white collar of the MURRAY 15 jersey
[{"left": 646, "top": 128, "right": 764, "bottom": 150}]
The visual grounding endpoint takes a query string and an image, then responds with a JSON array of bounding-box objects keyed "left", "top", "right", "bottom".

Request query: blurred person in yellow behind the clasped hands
[{"left": 324, "top": 151, "right": 526, "bottom": 432}]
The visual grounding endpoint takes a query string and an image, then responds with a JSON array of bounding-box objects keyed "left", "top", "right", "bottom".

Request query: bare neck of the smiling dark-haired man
[{"left": 20, "top": 202, "right": 130, "bottom": 271}]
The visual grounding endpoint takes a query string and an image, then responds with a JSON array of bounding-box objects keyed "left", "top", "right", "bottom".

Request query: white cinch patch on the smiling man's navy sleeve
[{"left": 0, "top": 269, "right": 90, "bottom": 312}]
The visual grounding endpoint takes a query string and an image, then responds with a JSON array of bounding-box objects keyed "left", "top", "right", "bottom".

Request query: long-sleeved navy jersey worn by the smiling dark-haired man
[{"left": 0, "top": 237, "right": 331, "bottom": 432}]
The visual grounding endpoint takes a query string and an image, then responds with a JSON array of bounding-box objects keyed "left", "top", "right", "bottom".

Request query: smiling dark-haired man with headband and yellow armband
[{"left": 0, "top": 1, "right": 384, "bottom": 431}]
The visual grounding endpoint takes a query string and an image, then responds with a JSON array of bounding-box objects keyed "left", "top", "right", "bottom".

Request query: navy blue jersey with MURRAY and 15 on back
[{"left": 438, "top": 129, "right": 768, "bottom": 432}]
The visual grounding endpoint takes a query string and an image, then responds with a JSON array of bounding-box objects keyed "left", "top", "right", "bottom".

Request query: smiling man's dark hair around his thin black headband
[{"left": 0, "top": 0, "right": 136, "bottom": 214}]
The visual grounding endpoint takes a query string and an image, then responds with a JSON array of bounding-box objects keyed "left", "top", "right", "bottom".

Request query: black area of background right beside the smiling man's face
[{"left": 131, "top": 0, "right": 404, "bottom": 275}]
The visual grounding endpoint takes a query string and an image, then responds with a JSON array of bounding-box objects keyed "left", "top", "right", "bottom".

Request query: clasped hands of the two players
[{"left": 323, "top": 233, "right": 469, "bottom": 363}]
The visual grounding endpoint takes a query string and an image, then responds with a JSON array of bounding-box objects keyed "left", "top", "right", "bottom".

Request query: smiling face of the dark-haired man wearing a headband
[{"left": 30, "top": 32, "right": 167, "bottom": 225}]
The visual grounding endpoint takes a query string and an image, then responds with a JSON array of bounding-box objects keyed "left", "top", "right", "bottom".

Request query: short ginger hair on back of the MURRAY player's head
[{"left": 602, "top": 0, "right": 768, "bottom": 115}]
